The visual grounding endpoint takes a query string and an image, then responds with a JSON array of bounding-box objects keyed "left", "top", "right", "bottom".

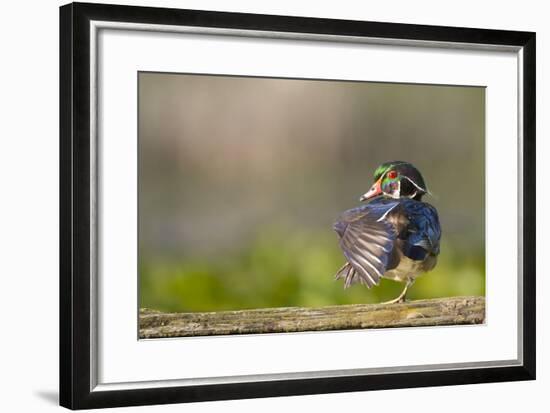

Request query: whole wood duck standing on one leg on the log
[{"left": 334, "top": 161, "right": 441, "bottom": 303}]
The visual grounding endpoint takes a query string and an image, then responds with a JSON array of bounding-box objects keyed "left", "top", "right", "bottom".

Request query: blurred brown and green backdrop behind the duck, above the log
[{"left": 138, "top": 72, "right": 485, "bottom": 311}]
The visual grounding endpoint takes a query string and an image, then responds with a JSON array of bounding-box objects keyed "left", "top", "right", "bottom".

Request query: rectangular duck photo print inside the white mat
[{"left": 138, "top": 72, "right": 485, "bottom": 338}]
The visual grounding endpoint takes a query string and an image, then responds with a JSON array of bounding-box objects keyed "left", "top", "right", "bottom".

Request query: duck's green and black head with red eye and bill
[{"left": 360, "top": 161, "right": 428, "bottom": 201}]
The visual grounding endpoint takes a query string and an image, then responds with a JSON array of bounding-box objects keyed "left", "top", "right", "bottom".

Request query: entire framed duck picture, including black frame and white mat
[{"left": 60, "top": 3, "right": 535, "bottom": 409}]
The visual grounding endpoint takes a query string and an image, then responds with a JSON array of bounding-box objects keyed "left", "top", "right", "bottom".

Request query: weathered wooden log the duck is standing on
[{"left": 139, "top": 297, "right": 485, "bottom": 338}]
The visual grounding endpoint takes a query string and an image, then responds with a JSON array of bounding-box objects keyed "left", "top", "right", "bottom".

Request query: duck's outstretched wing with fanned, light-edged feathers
[{"left": 334, "top": 201, "right": 399, "bottom": 288}]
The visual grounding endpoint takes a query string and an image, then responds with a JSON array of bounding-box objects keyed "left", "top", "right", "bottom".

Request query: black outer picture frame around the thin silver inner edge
[{"left": 59, "top": 3, "right": 536, "bottom": 409}]
